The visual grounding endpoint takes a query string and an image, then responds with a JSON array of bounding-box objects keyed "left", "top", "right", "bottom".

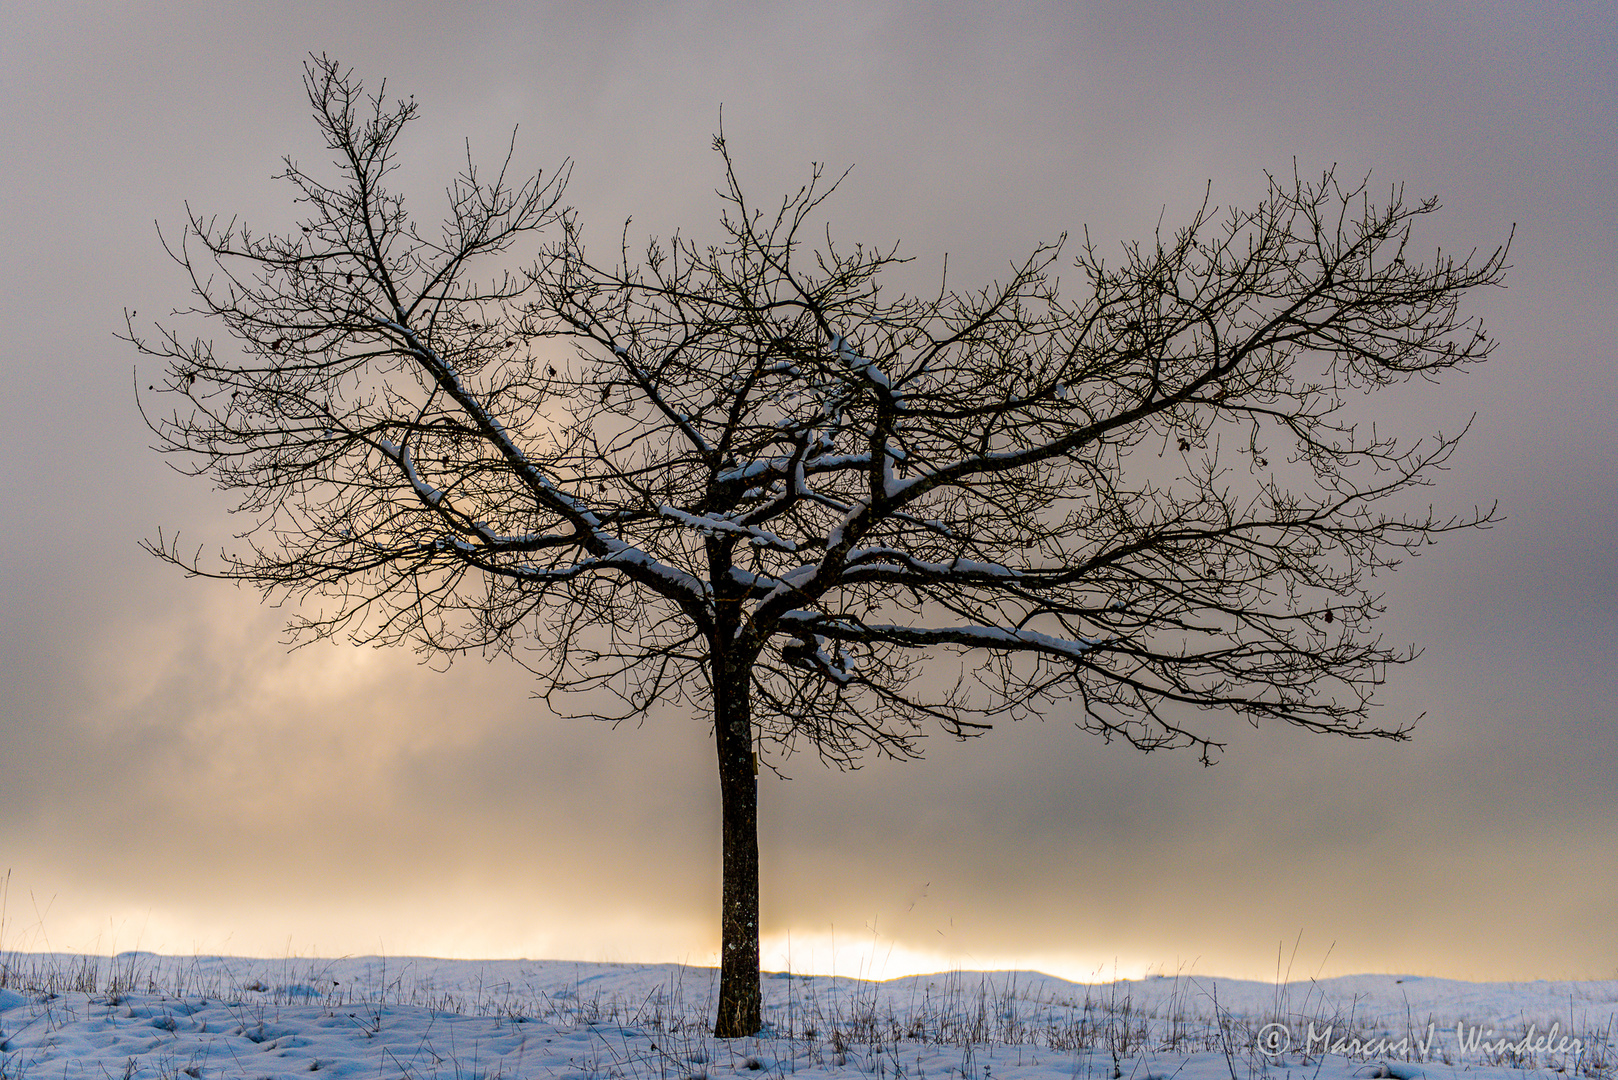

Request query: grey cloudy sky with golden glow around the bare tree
[{"left": 0, "top": 0, "right": 1618, "bottom": 980}]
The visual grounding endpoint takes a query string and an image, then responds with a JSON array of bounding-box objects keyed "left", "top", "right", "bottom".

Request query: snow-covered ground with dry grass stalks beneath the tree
[{"left": 0, "top": 954, "right": 1618, "bottom": 1080}]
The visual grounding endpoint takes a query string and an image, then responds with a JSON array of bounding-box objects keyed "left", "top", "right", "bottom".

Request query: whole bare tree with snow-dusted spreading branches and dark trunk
[{"left": 128, "top": 57, "right": 1506, "bottom": 1036}]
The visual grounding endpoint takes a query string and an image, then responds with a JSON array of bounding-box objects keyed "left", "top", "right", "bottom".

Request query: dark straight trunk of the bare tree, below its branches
[{"left": 714, "top": 657, "right": 764, "bottom": 1038}]
